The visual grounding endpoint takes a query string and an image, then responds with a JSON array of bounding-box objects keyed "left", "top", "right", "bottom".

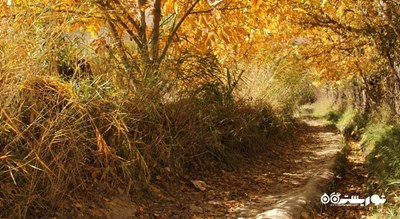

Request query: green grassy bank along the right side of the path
[{"left": 315, "top": 95, "right": 400, "bottom": 218}]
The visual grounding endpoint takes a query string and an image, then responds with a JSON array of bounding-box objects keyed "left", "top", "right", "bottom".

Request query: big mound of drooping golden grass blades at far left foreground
[{"left": 0, "top": 76, "right": 138, "bottom": 217}]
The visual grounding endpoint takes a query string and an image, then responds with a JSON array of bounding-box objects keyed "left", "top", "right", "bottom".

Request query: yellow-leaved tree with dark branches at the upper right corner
[{"left": 292, "top": 0, "right": 400, "bottom": 113}]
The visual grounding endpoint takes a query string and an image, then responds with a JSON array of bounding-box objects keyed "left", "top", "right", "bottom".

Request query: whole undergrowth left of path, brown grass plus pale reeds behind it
[{"left": 0, "top": 26, "right": 312, "bottom": 218}]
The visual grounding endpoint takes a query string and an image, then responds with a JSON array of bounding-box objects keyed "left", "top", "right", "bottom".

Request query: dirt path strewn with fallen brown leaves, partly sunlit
[{"left": 91, "top": 120, "right": 343, "bottom": 218}]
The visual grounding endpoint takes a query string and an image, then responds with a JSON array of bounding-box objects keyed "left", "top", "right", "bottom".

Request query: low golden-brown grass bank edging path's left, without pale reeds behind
[{"left": 0, "top": 65, "right": 290, "bottom": 217}]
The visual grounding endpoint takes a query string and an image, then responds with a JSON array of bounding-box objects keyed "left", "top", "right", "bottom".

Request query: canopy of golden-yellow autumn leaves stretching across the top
[{"left": 0, "top": 0, "right": 395, "bottom": 90}]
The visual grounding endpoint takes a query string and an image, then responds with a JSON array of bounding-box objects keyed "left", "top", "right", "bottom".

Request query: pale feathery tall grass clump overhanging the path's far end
[{"left": 239, "top": 49, "right": 317, "bottom": 115}]
